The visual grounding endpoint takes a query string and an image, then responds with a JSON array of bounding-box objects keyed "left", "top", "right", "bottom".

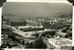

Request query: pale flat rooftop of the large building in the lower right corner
[{"left": 48, "top": 38, "right": 72, "bottom": 47}]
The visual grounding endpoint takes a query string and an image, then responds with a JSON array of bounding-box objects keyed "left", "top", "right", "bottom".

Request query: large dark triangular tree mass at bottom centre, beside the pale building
[{"left": 26, "top": 38, "right": 47, "bottom": 49}]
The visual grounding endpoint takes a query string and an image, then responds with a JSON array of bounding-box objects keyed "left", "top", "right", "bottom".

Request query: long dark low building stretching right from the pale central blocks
[{"left": 43, "top": 21, "right": 71, "bottom": 29}]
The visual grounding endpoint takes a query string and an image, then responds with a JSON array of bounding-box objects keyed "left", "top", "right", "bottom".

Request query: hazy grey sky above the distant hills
[{"left": 3, "top": 2, "right": 72, "bottom": 17}]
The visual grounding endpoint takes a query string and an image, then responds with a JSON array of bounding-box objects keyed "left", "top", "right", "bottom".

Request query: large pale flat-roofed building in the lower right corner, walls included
[{"left": 47, "top": 38, "right": 72, "bottom": 49}]
